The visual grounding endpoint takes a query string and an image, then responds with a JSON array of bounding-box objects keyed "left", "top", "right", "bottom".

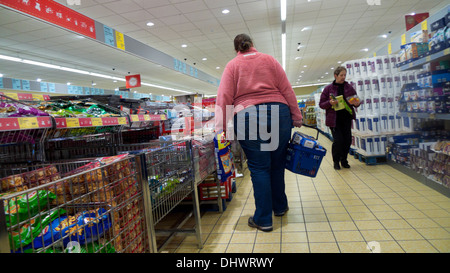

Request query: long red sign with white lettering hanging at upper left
[{"left": 0, "top": 0, "right": 96, "bottom": 39}]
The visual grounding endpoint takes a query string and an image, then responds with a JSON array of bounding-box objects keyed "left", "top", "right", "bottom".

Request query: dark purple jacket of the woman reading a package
[{"left": 319, "top": 82, "right": 356, "bottom": 127}]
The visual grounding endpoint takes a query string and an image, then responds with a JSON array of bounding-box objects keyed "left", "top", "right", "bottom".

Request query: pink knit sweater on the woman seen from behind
[{"left": 215, "top": 47, "right": 302, "bottom": 132}]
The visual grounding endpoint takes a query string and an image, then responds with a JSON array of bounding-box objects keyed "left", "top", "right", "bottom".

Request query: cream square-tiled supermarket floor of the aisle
[{"left": 163, "top": 127, "right": 450, "bottom": 253}]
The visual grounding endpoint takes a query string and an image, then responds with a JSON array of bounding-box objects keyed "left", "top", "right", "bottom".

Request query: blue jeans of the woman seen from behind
[{"left": 234, "top": 103, "right": 292, "bottom": 227}]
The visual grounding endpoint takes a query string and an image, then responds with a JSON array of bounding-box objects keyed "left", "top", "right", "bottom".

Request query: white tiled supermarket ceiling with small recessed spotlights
[{"left": 0, "top": 0, "right": 450, "bottom": 95}]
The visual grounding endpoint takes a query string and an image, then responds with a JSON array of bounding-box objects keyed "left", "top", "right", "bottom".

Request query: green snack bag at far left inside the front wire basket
[{"left": 5, "top": 190, "right": 56, "bottom": 227}]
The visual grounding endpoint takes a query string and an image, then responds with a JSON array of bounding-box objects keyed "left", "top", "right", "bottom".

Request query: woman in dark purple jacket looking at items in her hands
[{"left": 319, "top": 66, "right": 360, "bottom": 170}]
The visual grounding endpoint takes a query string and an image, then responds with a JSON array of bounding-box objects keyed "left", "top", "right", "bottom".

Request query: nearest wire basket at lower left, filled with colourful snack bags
[{"left": 0, "top": 155, "right": 149, "bottom": 253}]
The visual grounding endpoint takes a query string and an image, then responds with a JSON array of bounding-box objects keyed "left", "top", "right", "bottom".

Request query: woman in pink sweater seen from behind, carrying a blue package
[{"left": 215, "top": 34, "right": 302, "bottom": 231}]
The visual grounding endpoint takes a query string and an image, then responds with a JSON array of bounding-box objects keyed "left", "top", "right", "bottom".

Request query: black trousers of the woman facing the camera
[{"left": 330, "top": 119, "right": 352, "bottom": 163}]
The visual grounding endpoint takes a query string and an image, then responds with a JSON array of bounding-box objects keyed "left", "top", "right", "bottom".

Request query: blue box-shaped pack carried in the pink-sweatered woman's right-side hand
[{"left": 286, "top": 129, "right": 327, "bottom": 177}]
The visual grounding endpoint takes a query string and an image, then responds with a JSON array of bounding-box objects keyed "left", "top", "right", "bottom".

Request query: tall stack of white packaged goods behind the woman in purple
[{"left": 344, "top": 52, "right": 416, "bottom": 155}]
